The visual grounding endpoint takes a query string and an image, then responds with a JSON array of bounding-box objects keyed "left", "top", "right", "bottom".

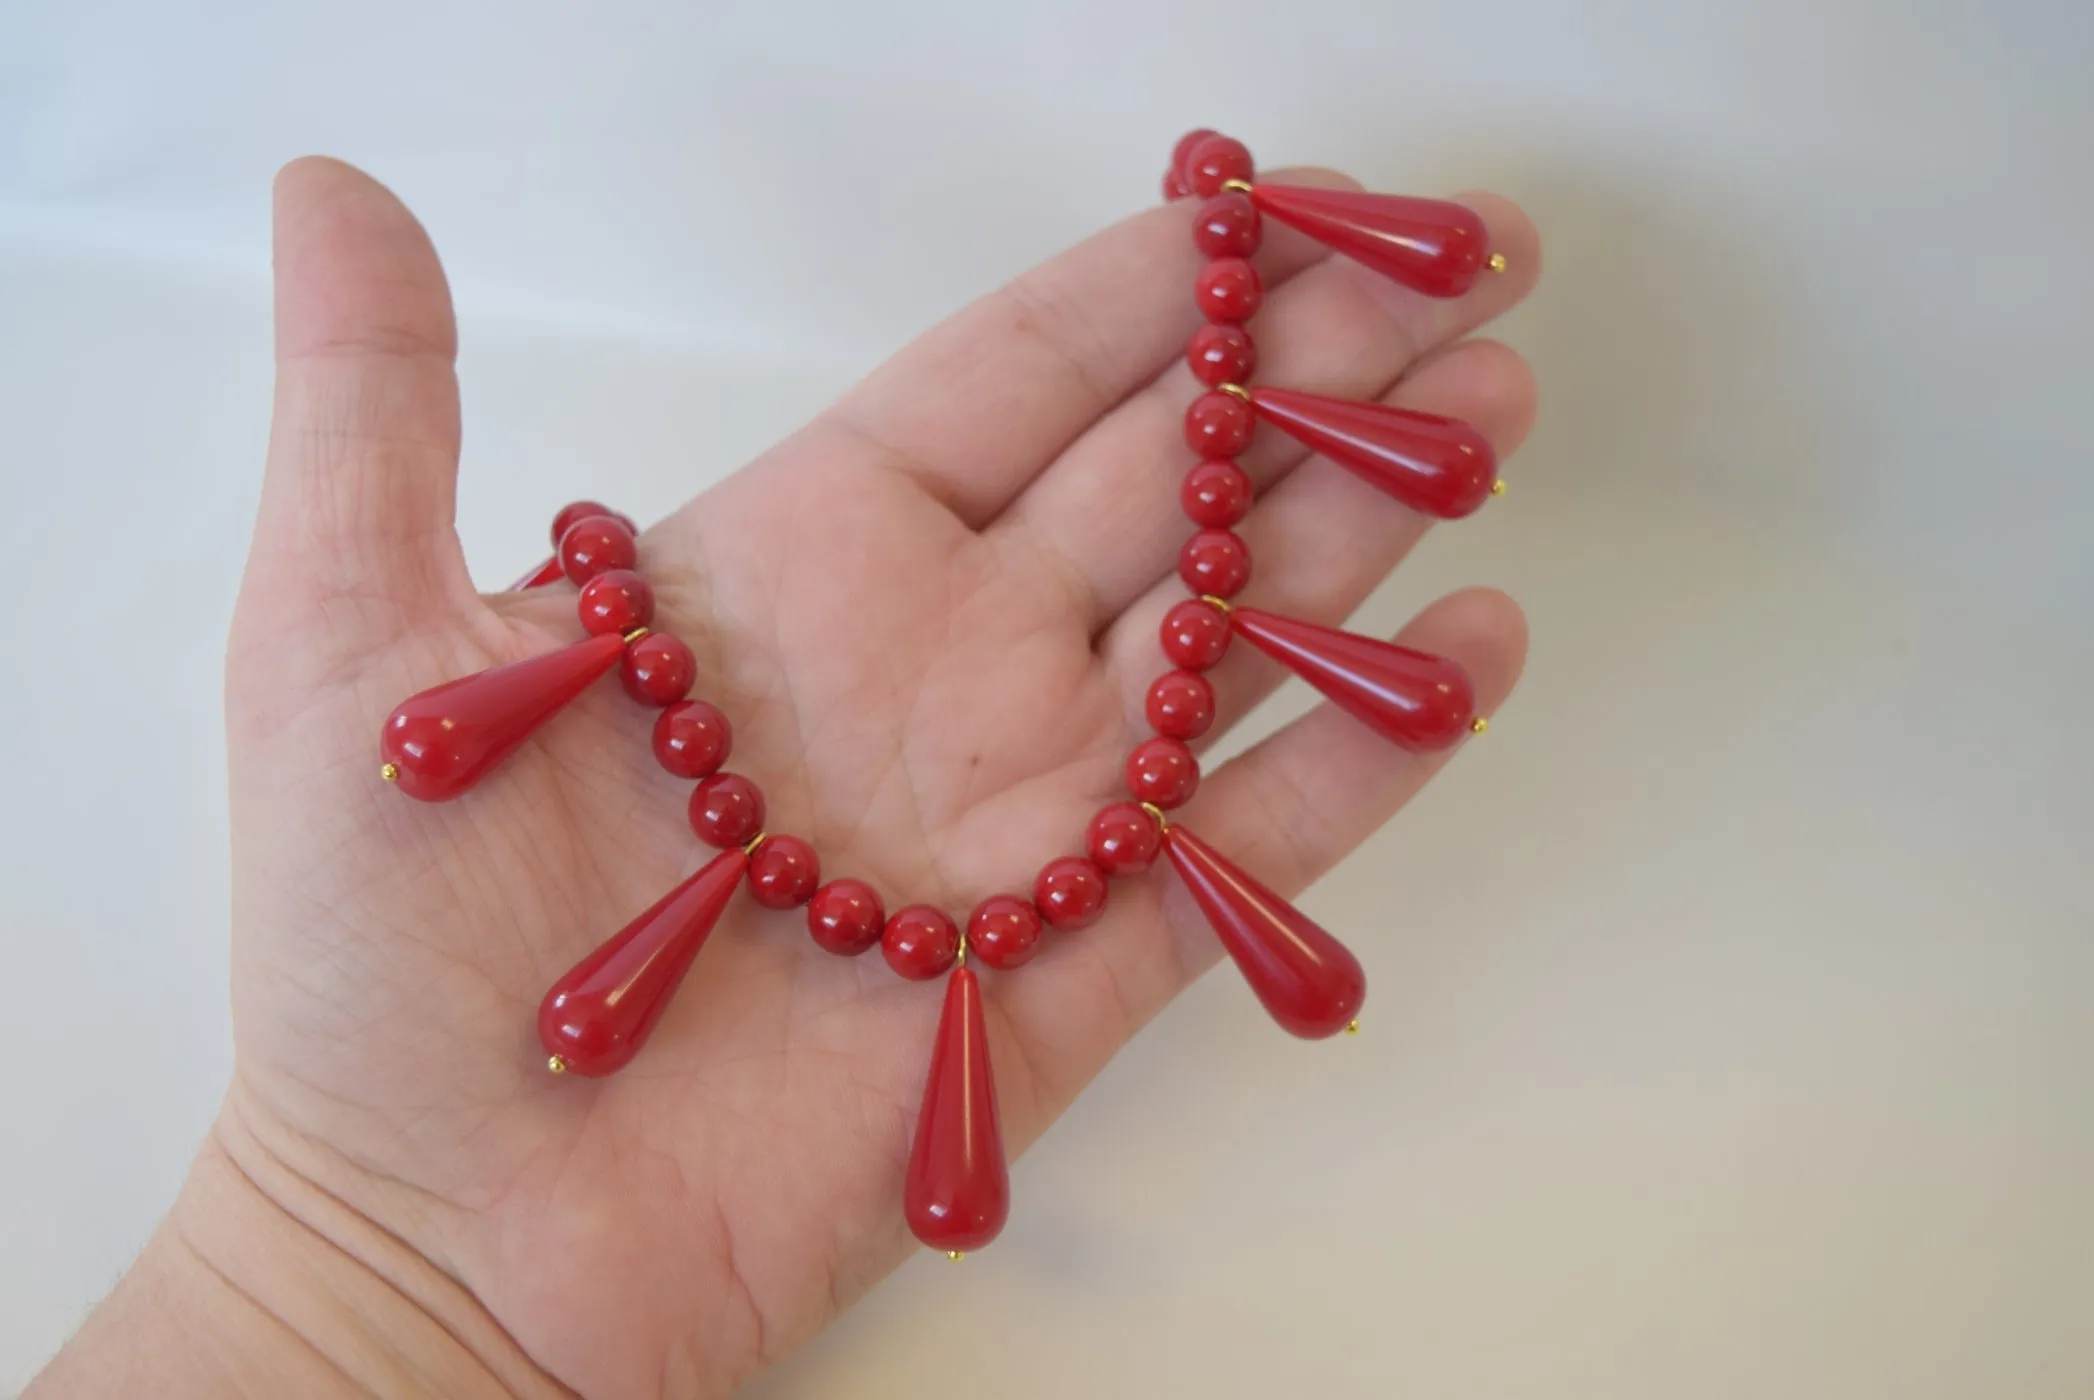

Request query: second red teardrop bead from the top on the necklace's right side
[{"left": 1250, "top": 389, "right": 1497, "bottom": 521}]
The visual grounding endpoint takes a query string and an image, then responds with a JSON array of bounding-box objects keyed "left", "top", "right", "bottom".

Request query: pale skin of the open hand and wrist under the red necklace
[{"left": 27, "top": 159, "right": 1539, "bottom": 1400}]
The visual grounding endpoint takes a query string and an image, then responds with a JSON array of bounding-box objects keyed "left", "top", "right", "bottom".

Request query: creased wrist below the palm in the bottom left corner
[{"left": 25, "top": 1107, "right": 572, "bottom": 1400}]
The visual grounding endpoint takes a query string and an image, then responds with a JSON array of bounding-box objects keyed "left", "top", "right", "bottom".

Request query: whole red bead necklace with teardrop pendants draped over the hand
[{"left": 379, "top": 130, "right": 1506, "bottom": 1260}]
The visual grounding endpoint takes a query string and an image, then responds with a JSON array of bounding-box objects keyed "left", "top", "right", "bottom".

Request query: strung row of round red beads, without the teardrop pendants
[{"left": 526, "top": 132, "right": 1263, "bottom": 981}]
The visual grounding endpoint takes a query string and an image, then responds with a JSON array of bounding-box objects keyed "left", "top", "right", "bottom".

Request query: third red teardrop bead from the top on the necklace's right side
[{"left": 1229, "top": 607, "right": 1476, "bottom": 751}]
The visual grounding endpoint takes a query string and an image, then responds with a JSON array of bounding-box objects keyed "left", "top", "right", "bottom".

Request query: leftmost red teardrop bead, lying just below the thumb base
[{"left": 379, "top": 634, "right": 626, "bottom": 801}]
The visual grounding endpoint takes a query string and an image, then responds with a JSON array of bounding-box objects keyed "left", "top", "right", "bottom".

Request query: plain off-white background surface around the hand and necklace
[{"left": 0, "top": 0, "right": 2094, "bottom": 1400}]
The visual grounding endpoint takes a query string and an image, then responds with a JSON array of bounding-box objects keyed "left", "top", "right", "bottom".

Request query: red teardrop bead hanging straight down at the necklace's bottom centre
[{"left": 903, "top": 967, "right": 1011, "bottom": 1254}]
